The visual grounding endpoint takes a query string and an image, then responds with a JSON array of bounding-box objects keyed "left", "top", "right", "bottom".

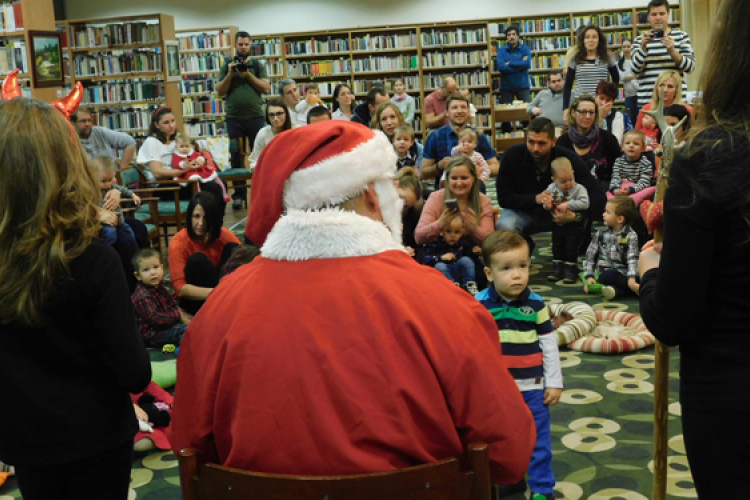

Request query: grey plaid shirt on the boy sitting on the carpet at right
[{"left": 585, "top": 225, "right": 639, "bottom": 278}]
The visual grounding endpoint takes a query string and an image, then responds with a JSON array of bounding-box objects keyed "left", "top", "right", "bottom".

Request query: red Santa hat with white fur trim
[{"left": 246, "top": 120, "right": 396, "bottom": 245}]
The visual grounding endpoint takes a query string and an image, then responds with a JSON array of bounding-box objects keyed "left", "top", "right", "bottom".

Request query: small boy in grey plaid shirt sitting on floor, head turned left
[{"left": 583, "top": 196, "right": 640, "bottom": 300}]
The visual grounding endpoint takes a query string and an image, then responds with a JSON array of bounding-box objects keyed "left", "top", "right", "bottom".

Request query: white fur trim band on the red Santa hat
[{"left": 284, "top": 130, "right": 397, "bottom": 210}]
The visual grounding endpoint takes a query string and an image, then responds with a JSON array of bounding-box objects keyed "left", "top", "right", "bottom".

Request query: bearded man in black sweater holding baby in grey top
[{"left": 495, "top": 117, "right": 607, "bottom": 251}]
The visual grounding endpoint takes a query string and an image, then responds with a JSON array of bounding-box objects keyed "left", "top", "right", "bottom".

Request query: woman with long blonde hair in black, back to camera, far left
[{"left": 0, "top": 98, "right": 151, "bottom": 500}]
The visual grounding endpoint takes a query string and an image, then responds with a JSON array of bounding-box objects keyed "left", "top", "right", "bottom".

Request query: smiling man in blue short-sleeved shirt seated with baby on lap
[{"left": 420, "top": 93, "right": 500, "bottom": 189}]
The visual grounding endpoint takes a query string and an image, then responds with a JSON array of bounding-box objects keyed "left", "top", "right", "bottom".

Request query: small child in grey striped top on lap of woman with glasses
[{"left": 607, "top": 129, "right": 656, "bottom": 207}]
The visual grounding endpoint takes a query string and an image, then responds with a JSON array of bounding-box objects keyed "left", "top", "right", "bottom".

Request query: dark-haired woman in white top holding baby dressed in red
[{"left": 136, "top": 106, "right": 225, "bottom": 209}]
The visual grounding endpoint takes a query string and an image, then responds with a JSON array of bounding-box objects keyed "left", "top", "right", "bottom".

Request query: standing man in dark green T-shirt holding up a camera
[{"left": 216, "top": 31, "right": 271, "bottom": 208}]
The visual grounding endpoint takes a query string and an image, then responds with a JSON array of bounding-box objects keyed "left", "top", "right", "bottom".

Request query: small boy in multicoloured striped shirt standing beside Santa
[{"left": 476, "top": 231, "right": 562, "bottom": 500}]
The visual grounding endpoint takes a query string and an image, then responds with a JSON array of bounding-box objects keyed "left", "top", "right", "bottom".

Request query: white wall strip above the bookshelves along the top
[{"left": 67, "top": 0, "right": 648, "bottom": 34}]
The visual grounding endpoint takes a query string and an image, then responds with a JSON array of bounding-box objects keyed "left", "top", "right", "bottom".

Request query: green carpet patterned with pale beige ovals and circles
[{"left": 0, "top": 180, "right": 697, "bottom": 500}]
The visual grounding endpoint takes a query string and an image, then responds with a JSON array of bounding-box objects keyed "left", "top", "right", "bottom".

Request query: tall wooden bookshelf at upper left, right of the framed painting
[{"left": 67, "top": 13, "right": 182, "bottom": 143}]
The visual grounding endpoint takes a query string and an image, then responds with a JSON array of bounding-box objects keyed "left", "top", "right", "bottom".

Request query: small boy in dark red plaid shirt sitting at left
[{"left": 130, "top": 248, "right": 190, "bottom": 347}]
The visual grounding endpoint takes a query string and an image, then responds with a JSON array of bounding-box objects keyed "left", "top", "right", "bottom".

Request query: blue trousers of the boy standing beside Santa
[{"left": 521, "top": 390, "right": 555, "bottom": 495}]
